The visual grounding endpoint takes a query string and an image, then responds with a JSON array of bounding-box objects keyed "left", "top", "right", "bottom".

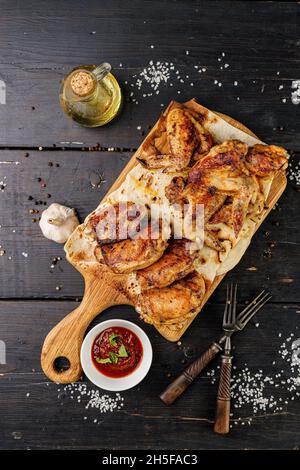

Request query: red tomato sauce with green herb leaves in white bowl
[{"left": 92, "top": 326, "right": 143, "bottom": 378}]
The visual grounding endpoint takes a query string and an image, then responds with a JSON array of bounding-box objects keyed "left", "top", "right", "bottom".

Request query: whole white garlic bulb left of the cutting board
[{"left": 40, "top": 203, "right": 79, "bottom": 243}]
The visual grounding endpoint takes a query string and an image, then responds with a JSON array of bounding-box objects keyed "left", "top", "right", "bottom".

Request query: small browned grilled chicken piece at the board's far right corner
[{"left": 246, "top": 144, "right": 288, "bottom": 177}]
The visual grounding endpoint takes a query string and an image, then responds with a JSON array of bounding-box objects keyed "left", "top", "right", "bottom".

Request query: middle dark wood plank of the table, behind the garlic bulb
[{"left": 0, "top": 150, "right": 300, "bottom": 302}]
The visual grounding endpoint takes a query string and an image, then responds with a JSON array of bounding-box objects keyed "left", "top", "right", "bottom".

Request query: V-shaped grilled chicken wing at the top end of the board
[{"left": 138, "top": 108, "right": 213, "bottom": 171}]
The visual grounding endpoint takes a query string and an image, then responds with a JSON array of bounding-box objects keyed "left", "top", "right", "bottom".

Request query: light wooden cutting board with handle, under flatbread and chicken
[{"left": 41, "top": 100, "right": 287, "bottom": 383}]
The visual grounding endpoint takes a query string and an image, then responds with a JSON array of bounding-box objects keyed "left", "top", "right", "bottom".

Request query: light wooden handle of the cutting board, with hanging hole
[{"left": 41, "top": 279, "right": 128, "bottom": 383}]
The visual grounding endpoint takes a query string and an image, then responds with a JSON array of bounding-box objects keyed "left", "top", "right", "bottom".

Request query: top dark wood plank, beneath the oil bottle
[{"left": 0, "top": 0, "right": 300, "bottom": 149}]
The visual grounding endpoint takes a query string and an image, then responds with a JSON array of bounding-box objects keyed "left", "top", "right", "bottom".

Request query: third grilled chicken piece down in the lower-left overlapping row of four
[{"left": 136, "top": 239, "right": 196, "bottom": 291}]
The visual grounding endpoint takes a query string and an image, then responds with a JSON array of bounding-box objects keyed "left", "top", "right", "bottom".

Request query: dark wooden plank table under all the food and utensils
[{"left": 0, "top": 0, "right": 300, "bottom": 449}]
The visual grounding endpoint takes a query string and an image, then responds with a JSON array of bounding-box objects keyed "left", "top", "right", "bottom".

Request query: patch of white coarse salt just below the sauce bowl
[{"left": 58, "top": 382, "right": 124, "bottom": 416}]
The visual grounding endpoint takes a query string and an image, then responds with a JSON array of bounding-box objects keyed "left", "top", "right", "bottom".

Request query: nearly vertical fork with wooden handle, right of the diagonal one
[{"left": 214, "top": 284, "right": 237, "bottom": 434}]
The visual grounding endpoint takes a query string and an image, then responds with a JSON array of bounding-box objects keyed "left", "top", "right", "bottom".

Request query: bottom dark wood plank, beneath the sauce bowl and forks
[{"left": 0, "top": 301, "right": 300, "bottom": 449}]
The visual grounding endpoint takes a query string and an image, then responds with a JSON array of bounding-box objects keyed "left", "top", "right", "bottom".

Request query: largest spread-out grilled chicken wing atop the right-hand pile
[{"left": 166, "top": 140, "right": 257, "bottom": 237}]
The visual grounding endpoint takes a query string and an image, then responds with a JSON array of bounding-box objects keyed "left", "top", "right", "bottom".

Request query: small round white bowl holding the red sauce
[{"left": 80, "top": 319, "right": 153, "bottom": 392}]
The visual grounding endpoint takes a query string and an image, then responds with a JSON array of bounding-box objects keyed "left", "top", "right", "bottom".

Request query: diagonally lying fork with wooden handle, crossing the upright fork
[{"left": 160, "top": 291, "right": 271, "bottom": 405}]
